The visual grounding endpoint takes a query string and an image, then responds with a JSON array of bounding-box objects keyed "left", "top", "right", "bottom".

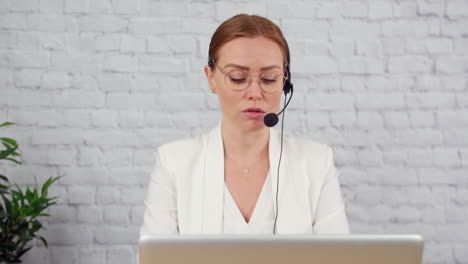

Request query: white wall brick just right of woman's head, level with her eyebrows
[{"left": 294, "top": 56, "right": 338, "bottom": 74}]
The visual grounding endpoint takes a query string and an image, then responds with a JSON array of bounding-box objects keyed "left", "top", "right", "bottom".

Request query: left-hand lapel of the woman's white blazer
[{"left": 202, "top": 123, "right": 224, "bottom": 234}]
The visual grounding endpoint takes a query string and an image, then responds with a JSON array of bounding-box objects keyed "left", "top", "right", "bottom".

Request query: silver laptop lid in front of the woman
[{"left": 138, "top": 235, "right": 424, "bottom": 264}]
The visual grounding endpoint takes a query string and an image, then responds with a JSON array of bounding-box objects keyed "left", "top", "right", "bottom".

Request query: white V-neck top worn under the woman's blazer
[{"left": 223, "top": 173, "right": 275, "bottom": 234}]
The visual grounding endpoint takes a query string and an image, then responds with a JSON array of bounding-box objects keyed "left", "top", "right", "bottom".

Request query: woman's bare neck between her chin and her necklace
[{"left": 221, "top": 121, "right": 270, "bottom": 161}]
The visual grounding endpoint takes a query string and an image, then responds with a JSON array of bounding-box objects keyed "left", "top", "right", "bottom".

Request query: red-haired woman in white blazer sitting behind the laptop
[{"left": 141, "top": 14, "right": 349, "bottom": 235}]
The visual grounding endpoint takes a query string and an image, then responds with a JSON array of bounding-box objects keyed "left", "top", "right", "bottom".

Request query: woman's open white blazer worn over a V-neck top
[{"left": 140, "top": 124, "right": 349, "bottom": 236}]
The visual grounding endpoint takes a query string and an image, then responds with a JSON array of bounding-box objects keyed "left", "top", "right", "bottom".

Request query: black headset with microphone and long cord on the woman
[{"left": 208, "top": 42, "right": 294, "bottom": 234}]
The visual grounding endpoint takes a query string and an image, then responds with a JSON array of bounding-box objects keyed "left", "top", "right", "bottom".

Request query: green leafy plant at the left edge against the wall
[{"left": 0, "top": 122, "right": 59, "bottom": 263}]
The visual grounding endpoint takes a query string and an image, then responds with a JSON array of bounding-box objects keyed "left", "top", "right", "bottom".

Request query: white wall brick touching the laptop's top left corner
[{"left": 95, "top": 226, "right": 139, "bottom": 246}]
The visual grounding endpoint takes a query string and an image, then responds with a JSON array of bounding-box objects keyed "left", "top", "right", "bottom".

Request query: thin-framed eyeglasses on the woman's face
[{"left": 215, "top": 61, "right": 288, "bottom": 93}]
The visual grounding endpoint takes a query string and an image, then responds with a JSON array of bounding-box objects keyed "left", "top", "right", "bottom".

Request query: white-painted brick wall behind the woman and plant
[{"left": 0, "top": 0, "right": 468, "bottom": 264}]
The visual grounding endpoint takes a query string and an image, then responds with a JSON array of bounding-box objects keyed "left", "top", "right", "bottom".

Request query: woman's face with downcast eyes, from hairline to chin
[{"left": 205, "top": 37, "right": 284, "bottom": 132}]
